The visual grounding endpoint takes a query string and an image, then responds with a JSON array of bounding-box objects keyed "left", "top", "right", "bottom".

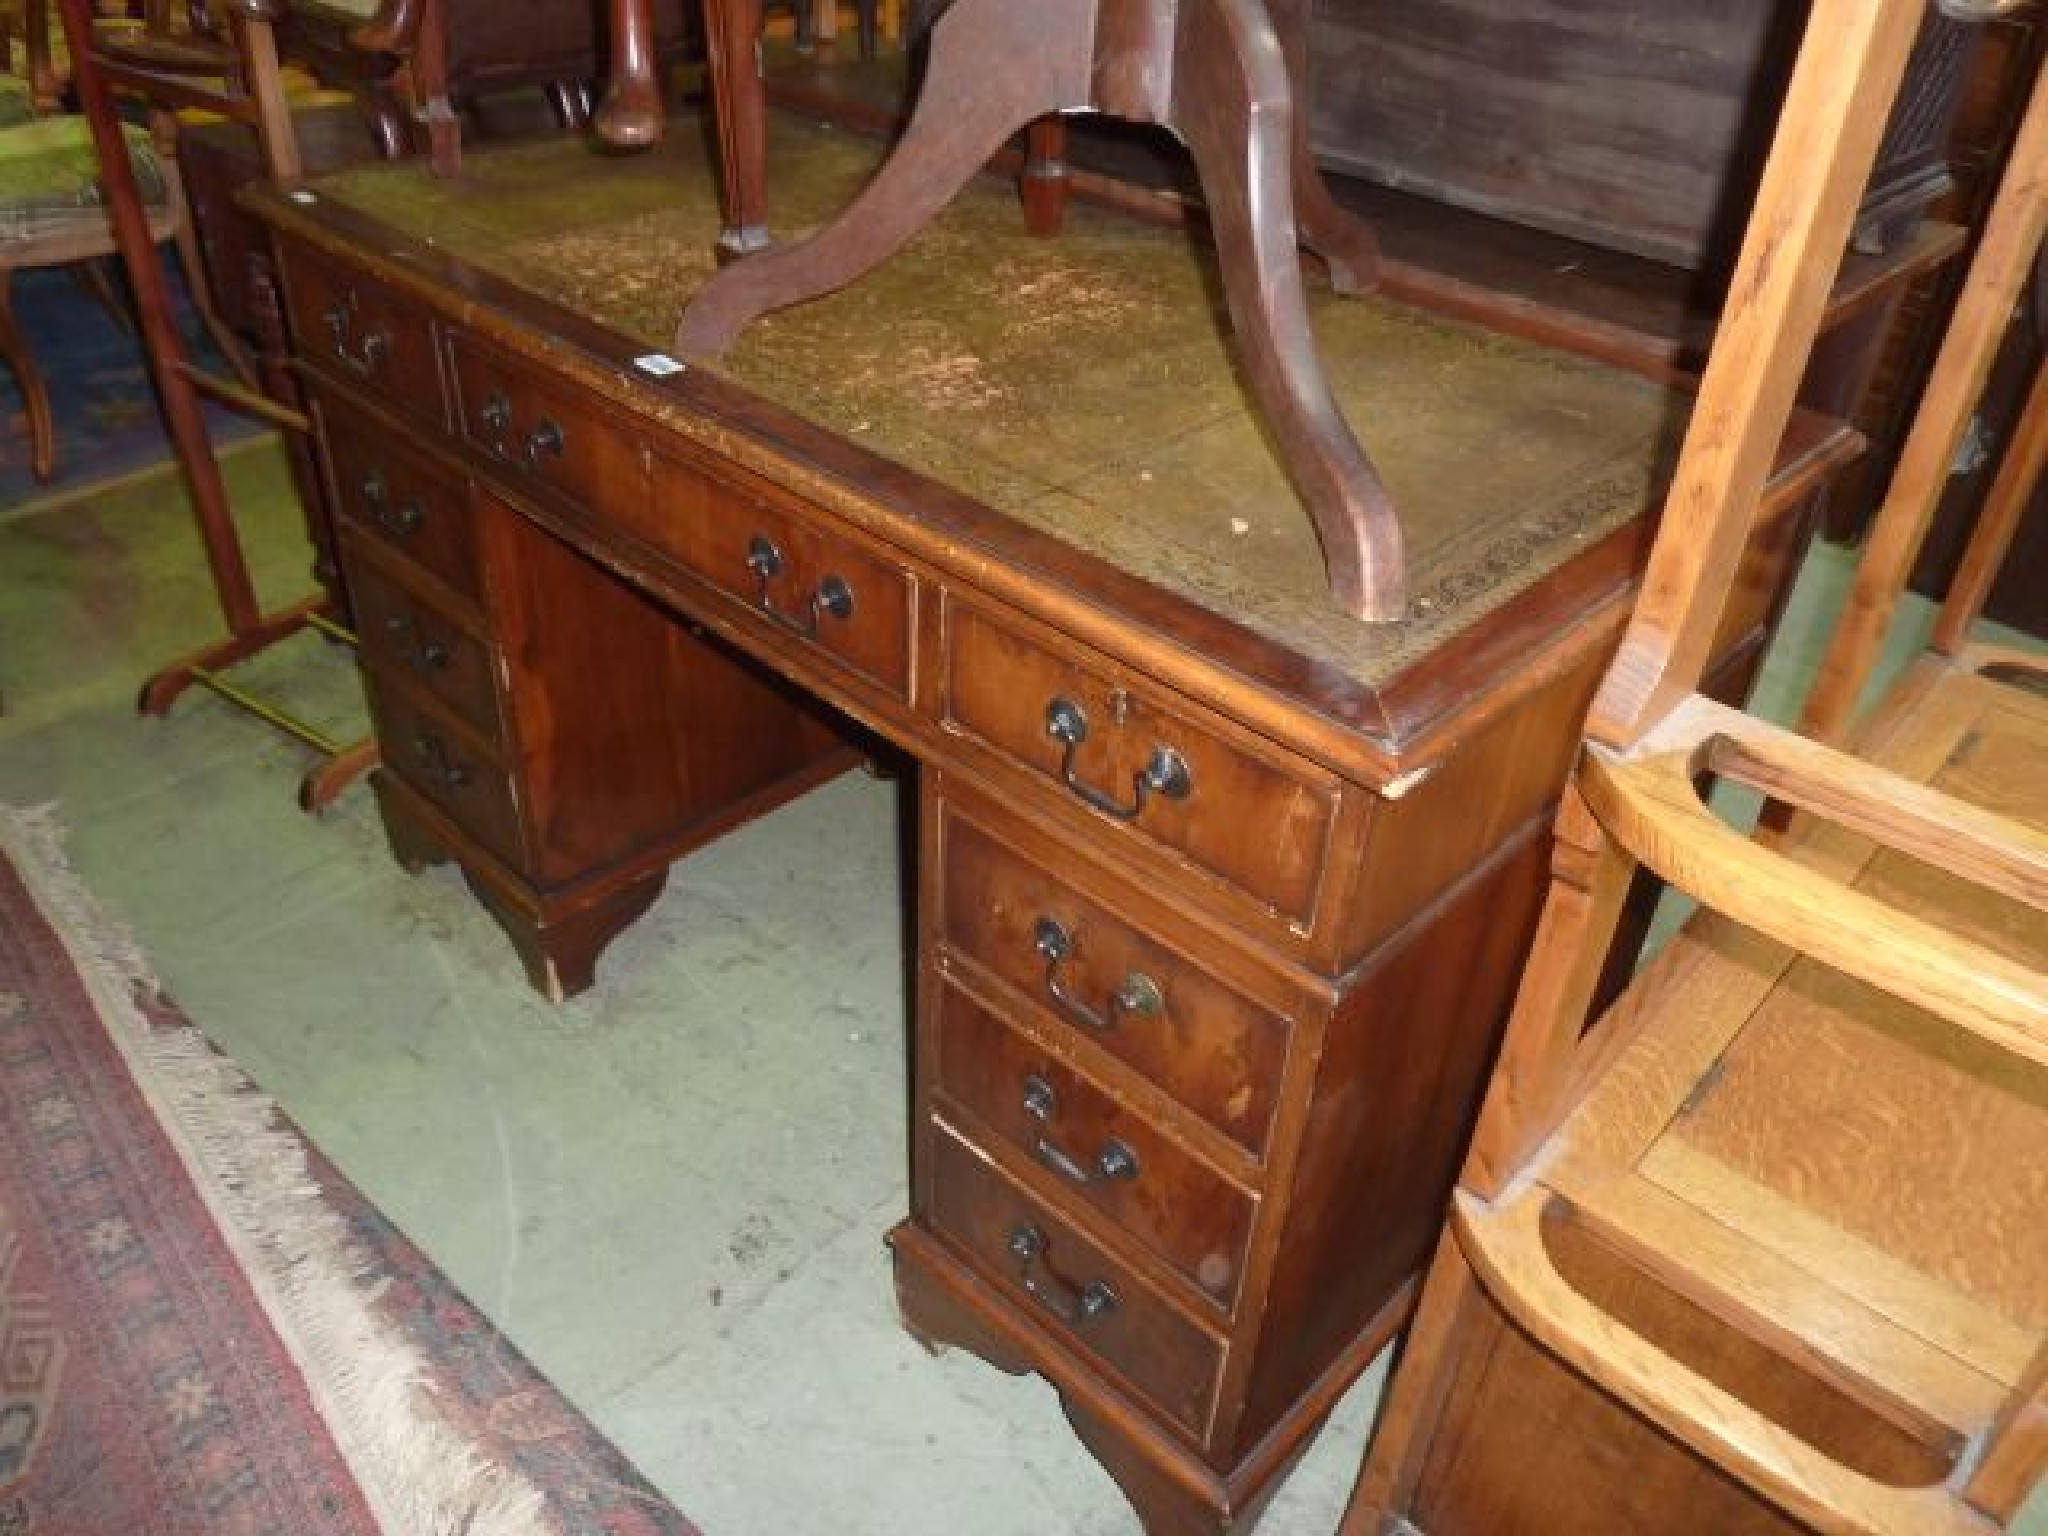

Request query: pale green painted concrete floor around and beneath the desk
[{"left": 0, "top": 444, "right": 2048, "bottom": 1536}]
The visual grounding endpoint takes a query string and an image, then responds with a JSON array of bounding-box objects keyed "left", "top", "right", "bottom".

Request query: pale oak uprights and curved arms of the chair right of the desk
[{"left": 1343, "top": 0, "right": 2048, "bottom": 1536}]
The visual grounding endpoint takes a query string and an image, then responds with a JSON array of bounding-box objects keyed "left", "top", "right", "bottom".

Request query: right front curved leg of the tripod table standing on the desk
[{"left": 1171, "top": 0, "right": 1407, "bottom": 621}]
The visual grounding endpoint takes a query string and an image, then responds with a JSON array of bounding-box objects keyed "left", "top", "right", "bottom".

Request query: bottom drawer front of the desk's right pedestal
[{"left": 928, "top": 1122, "right": 1223, "bottom": 1442}]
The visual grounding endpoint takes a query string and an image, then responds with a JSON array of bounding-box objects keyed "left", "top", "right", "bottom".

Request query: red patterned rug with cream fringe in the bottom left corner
[{"left": 0, "top": 807, "right": 696, "bottom": 1536}]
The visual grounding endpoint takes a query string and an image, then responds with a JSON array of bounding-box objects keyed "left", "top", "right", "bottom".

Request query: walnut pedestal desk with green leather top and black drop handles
[{"left": 254, "top": 125, "right": 1853, "bottom": 1532}]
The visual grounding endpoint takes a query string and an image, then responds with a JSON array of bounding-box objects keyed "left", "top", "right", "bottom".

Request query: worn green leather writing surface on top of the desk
[{"left": 319, "top": 121, "right": 1683, "bottom": 684}]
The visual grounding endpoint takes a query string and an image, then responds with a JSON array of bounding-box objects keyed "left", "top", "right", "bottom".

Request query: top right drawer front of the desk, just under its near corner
[{"left": 946, "top": 600, "right": 1337, "bottom": 932}]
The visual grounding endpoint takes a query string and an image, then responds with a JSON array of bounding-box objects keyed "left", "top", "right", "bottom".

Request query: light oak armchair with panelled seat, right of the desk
[{"left": 1343, "top": 0, "right": 2048, "bottom": 1536}]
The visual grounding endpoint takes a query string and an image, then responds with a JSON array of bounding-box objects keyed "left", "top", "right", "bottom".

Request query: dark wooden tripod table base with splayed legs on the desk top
[{"left": 676, "top": 0, "right": 1407, "bottom": 621}]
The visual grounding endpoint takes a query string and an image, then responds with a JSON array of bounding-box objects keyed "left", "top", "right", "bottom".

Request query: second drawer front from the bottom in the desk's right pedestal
[{"left": 938, "top": 987, "right": 1257, "bottom": 1311}]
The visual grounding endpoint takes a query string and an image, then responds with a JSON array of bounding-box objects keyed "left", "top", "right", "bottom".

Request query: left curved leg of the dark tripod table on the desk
[{"left": 674, "top": 0, "right": 1092, "bottom": 358}]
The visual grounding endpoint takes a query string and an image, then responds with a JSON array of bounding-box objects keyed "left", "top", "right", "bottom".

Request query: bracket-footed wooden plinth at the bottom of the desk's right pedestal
[{"left": 889, "top": 1221, "right": 1368, "bottom": 1536}]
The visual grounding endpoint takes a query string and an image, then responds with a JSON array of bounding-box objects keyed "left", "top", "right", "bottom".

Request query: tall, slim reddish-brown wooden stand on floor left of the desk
[{"left": 61, "top": 0, "right": 375, "bottom": 809}]
